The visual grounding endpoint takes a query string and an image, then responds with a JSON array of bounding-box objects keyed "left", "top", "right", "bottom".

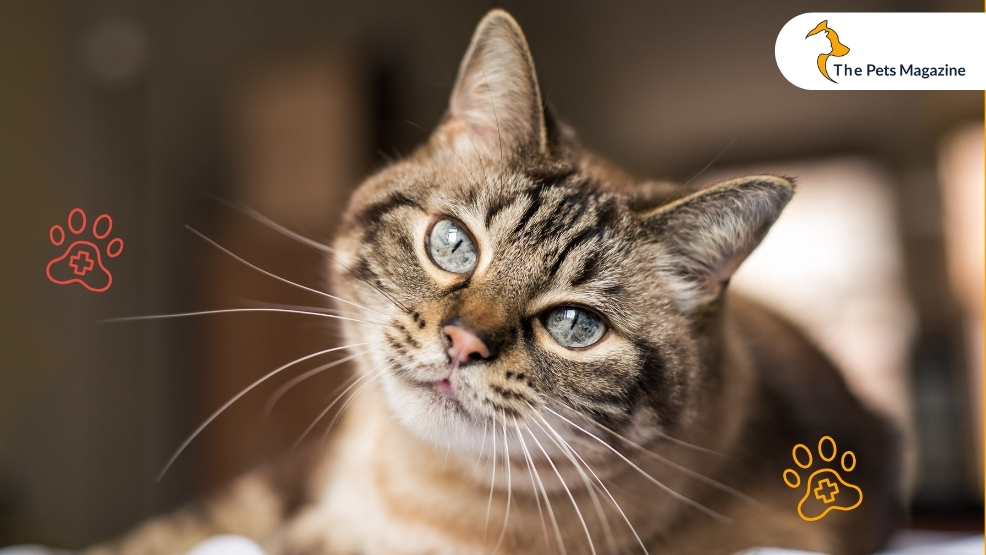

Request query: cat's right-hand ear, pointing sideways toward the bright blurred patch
[{"left": 644, "top": 175, "right": 794, "bottom": 309}]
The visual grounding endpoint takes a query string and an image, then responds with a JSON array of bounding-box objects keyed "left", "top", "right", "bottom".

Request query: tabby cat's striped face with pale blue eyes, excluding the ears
[{"left": 330, "top": 153, "right": 693, "bottom": 447}]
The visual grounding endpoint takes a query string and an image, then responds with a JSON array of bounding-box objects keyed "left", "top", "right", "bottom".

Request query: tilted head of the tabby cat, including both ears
[{"left": 333, "top": 10, "right": 793, "bottom": 448}]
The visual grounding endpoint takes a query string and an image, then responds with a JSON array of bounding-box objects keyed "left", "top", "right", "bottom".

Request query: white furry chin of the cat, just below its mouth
[{"left": 382, "top": 374, "right": 491, "bottom": 452}]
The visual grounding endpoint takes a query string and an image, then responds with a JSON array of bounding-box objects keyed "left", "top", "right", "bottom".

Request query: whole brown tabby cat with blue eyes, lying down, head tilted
[{"left": 89, "top": 10, "right": 902, "bottom": 555}]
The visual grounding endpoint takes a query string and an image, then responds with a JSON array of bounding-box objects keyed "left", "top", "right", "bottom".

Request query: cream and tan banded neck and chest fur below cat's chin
[{"left": 326, "top": 382, "right": 708, "bottom": 553}]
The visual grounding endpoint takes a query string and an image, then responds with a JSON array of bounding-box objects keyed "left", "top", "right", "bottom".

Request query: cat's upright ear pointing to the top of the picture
[{"left": 435, "top": 9, "right": 547, "bottom": 157}]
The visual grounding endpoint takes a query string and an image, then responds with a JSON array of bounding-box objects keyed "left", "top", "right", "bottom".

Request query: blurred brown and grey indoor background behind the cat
[{"left": 0, "top": 0, "right": 984, "bottom": 547}]
